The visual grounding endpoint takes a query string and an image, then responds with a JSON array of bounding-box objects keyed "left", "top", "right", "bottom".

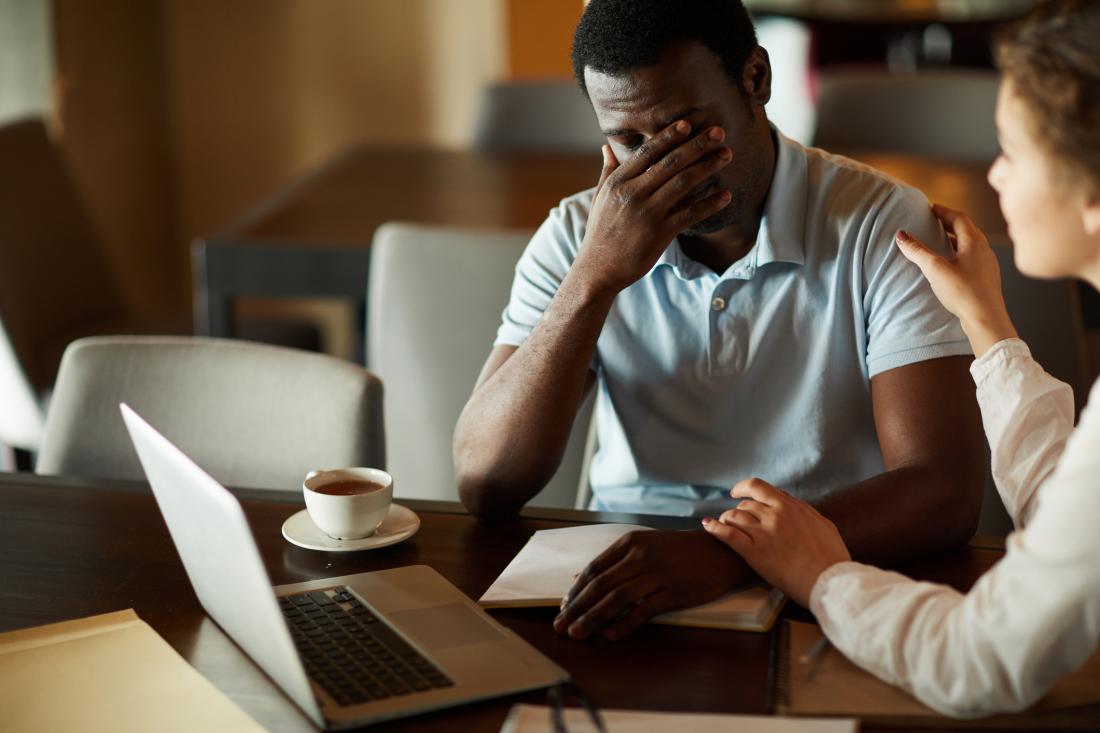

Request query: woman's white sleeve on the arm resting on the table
[{"left": 810, "top": 374, "right": 1100, "bottom": 718}]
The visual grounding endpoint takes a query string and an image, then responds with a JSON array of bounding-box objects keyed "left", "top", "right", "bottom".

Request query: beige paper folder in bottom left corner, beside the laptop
[{"left": 0, "top": 610, "right": 264, "bottom": 733}]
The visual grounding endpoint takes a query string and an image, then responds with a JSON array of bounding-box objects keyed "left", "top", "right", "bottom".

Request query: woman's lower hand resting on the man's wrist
[{"left": 703, "top": 479, "right": 851, "bottom": 608}]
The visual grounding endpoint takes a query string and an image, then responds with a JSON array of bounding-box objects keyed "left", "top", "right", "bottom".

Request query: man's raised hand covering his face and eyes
[{"left": 573, "top": 120, "right": 733, "bottom": 293}]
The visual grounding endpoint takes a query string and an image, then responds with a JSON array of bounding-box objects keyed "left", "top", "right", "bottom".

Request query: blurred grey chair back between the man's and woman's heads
[{"left": 814, "top": 69, "right": 999, "bottom": 161}]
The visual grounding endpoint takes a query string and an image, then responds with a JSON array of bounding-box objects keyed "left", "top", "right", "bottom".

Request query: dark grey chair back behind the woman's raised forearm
[{"left": 978, "top": 238, "right": 1089, "bottom": 535}]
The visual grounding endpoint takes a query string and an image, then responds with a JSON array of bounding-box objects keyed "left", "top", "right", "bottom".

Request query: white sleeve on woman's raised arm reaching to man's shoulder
[{"left": 970, "top": 339, "right": 1074, "bottom": 528}]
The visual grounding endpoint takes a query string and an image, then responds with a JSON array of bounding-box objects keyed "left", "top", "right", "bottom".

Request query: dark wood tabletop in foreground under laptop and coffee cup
[{"left": 0, "top": 473, "right": 1000, "bottom": 732}]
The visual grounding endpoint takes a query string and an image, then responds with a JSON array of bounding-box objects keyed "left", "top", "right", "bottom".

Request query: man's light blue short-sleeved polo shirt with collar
[{"left": 496, "top": 132, "right": 970, "bottom": 516}]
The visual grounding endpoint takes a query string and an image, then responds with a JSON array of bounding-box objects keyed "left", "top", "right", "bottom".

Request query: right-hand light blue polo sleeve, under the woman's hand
[{"left": 864, "top": 185, "right": 972, "bottom": 378}]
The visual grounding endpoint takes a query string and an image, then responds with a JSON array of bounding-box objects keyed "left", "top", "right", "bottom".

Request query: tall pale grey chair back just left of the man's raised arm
[{"left": 367, "top": 223, "right": 592, "bottom": 507}]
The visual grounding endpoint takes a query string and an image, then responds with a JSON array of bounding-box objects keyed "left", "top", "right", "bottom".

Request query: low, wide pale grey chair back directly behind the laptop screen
[{"left": 36, "top": 337, "right": 385, "bottom": 491}]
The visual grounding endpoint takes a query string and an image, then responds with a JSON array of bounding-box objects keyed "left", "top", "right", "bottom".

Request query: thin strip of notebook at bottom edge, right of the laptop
[{"left": 501, "top": 704, "right": 857, "bottom": 733}]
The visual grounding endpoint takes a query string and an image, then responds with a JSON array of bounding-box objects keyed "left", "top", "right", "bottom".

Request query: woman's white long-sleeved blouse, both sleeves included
[{"left": 810, "top": 339, "right": 1100, "bottom": 718}]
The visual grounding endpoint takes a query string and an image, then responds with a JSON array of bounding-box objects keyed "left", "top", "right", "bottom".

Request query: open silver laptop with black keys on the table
[{"left": 121, "top": 405, "right": 569, "bottom": 730}]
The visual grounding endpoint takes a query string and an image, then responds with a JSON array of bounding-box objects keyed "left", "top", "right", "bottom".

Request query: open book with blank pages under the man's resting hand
[{"left": 477, "top": 524, "right": 785, "bottom": 632}]
